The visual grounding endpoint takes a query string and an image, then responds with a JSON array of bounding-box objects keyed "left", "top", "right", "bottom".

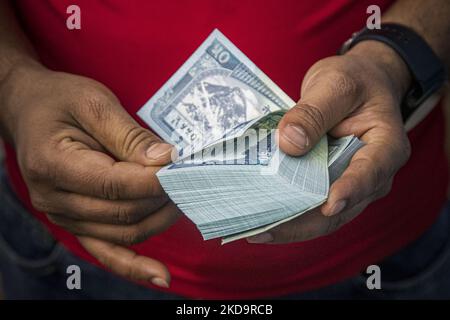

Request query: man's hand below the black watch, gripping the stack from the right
[{"left": 248, "top": 41, "right": 410, "bottom": 243}]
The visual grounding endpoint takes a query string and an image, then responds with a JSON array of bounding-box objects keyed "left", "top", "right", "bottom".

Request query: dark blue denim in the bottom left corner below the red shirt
[{"left": 0, "top": 173, "right": 179, "bottom": 299}]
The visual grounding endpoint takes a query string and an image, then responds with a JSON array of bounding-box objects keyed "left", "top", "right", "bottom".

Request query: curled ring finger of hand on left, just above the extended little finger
[{"left": 48, "top": 202, "right": 180, "bottom": 245}]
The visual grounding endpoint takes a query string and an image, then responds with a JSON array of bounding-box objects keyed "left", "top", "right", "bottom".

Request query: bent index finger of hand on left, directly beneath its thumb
[{"left": 51, "top": 146, "right": 165, "bottom": 200}]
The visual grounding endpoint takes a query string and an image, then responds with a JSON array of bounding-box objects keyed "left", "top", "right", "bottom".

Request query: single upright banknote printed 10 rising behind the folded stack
[{"left": 138, "top": 29, "right": 295, "bottom": 157}]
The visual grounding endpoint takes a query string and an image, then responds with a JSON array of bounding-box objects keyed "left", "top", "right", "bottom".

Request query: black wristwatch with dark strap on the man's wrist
[{"left": 338, "top": 23, "right": 447, "bottom": 122}]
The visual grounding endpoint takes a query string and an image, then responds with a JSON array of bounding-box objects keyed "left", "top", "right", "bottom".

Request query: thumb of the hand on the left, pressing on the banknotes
[{"left": 71, "top": 88, "right": 173, "bottom": 166}]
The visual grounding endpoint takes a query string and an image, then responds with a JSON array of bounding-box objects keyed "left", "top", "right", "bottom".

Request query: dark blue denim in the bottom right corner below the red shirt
[{"left": 282, "top": 201, "right": 450, "bottom": 300}]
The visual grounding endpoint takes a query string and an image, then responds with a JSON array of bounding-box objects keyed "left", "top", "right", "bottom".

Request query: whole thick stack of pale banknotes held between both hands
[{"left": 138, "top": 30, "right": 363, "bottom": 243}]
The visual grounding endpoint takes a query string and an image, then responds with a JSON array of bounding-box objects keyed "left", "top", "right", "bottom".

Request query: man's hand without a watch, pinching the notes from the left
[{"left": 0, "top": 64, "right": 179, "bottom": 287}]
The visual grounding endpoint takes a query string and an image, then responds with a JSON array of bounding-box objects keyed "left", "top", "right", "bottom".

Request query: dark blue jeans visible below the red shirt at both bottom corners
[{"left": 0, "top": 170, "right": 450, "bottom": 299}]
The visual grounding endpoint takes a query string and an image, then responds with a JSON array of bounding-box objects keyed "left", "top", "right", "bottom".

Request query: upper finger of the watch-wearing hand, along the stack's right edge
[{"left": 321, "top": 127, "right": 410, "bottom": 216}]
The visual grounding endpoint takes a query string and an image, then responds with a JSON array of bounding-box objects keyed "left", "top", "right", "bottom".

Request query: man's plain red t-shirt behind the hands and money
[{"left": 7, "top": 0, "right": 448, "bottom": 298}]
